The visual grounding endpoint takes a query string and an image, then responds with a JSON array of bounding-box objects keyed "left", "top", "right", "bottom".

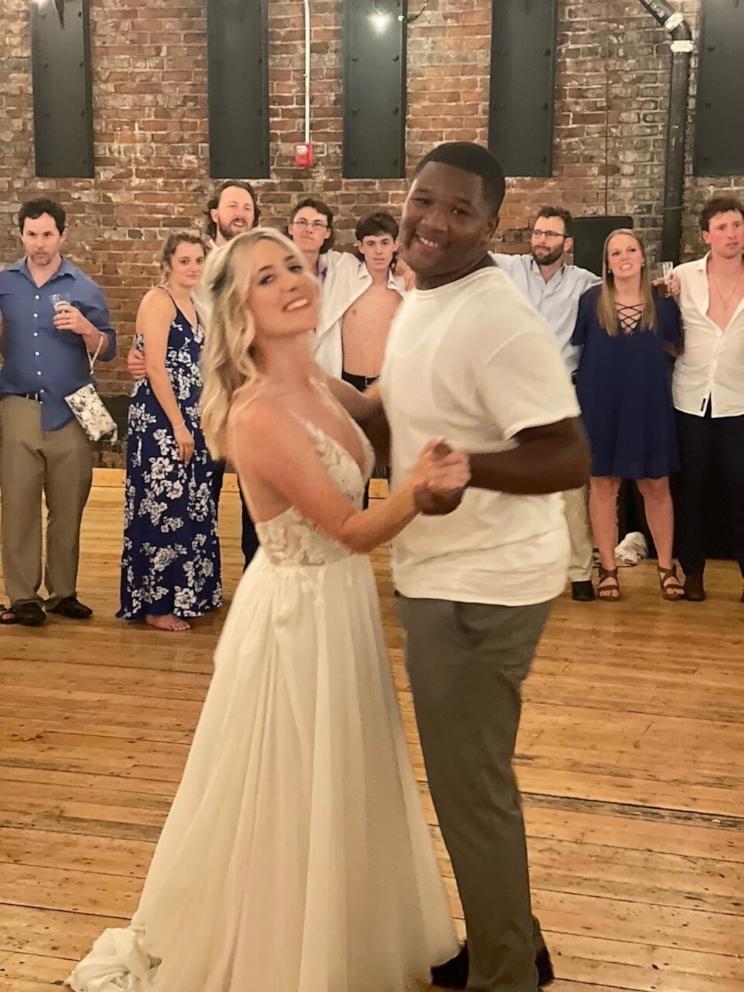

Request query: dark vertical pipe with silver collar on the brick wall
[{"left": 640, "top": 0, "right": 693, "bottom": 263}]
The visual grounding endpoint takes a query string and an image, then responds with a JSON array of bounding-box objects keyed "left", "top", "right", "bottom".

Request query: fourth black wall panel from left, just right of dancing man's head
[{"left": 488, "top": 0, "right": 558, "bottom": 176}]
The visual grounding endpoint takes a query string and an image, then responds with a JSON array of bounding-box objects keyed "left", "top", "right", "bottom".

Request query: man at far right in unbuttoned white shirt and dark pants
[{"left": 672, "top": 196, "right": 744, "bottom": 602}]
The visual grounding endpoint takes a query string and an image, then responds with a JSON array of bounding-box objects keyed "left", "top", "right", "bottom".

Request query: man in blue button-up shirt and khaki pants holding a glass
[{"left": 0, "top": 199, "right": 116, "bottom": 626}]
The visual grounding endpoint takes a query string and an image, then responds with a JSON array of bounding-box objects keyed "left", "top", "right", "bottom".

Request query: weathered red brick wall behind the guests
[{"left": 0, "top": 0, "right": 744, "bottom": 406}]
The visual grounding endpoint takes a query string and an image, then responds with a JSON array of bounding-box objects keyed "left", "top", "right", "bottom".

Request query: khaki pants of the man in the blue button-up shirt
[{"left": 0, "top": 396, "right": 93, "bottom": 607}]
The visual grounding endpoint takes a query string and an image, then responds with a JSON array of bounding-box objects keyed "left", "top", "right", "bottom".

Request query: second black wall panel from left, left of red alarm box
[{"left": 207, "top": 0, "right": 269, "bottom": 179}]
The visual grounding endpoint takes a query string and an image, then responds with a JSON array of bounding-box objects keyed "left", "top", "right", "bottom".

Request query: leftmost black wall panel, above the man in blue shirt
[{"left": 31, "top": 0, "right": 94, "bottom": 178}]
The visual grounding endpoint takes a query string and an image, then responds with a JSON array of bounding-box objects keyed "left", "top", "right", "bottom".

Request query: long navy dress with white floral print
[{"left": 117, "top": 303, "right": 222, "bottom": 620}]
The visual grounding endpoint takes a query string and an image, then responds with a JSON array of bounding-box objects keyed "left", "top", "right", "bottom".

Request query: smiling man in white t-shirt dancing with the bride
[{"left": 380, "top": 142, "right": 588, "bottom": 992}]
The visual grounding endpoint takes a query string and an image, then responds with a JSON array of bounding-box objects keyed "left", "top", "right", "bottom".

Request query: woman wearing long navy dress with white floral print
[{"left": 117, "top": 234, "right": 222, "bottom": 631}]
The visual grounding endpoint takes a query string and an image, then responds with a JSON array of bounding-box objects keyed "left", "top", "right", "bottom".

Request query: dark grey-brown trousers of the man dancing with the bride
[{"left": 398, "top": 596, "right": 550, "bottom": 992}]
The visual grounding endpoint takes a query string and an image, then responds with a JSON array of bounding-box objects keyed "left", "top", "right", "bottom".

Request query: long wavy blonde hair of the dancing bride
[{"left": 198, "top": 227, "right": 306, "bottom": 458}]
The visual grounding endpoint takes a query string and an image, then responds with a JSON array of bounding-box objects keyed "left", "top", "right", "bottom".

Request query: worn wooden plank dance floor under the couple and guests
[{"left": 0, "top": 474, "right": 744, "bottom": 992}]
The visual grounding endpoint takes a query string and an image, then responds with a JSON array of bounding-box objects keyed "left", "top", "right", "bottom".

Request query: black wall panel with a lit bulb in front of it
[{"left": 343, "top": 0, "right": 406, "bottom": 179}]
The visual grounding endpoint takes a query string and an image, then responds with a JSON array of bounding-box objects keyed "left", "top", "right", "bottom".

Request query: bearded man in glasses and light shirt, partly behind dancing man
[{"left": 491, "top": 206, "right": 601, "bottom": 603}]
